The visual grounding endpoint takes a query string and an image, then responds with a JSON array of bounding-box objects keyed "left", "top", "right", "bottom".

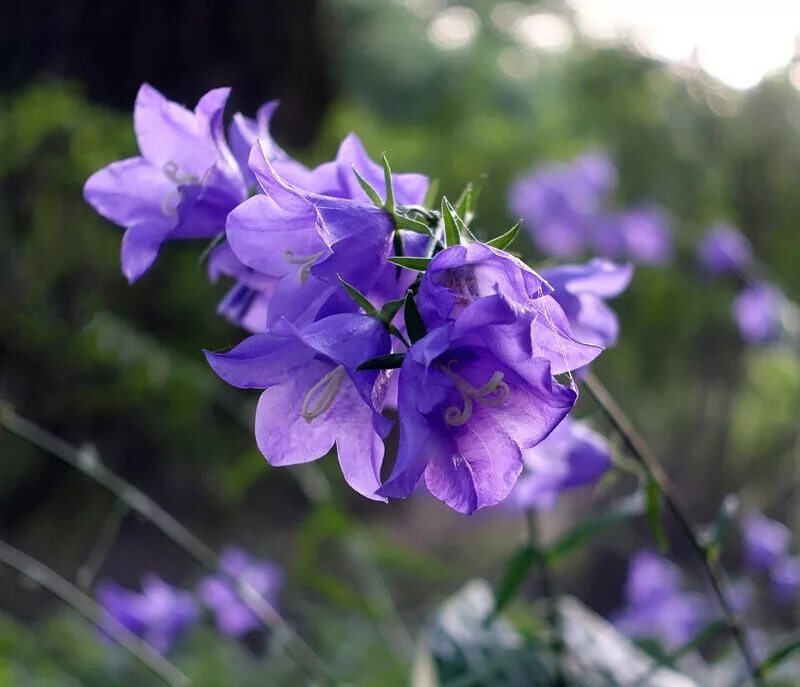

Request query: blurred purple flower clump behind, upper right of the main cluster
[{"left": 509, "top": 151, "right": 673, "bottom": 265}]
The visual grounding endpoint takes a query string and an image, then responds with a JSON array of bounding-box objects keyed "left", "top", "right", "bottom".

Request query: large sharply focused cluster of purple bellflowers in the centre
[{"left": 85, "top": 85, "right": 620, "bottom": 512}]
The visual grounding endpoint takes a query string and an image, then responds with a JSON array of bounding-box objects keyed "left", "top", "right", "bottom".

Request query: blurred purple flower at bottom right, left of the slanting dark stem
[{"left": 612, "top": 551, "right": 708, "bottom": 650}]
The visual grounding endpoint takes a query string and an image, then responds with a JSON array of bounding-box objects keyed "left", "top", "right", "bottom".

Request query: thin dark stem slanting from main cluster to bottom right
[{"left": 583, "top": 372, "right": 764, "bottom": 687}]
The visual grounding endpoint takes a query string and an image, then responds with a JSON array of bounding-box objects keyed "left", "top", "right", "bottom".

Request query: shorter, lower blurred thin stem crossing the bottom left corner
[{"left": 0, "top": 540, "right": 191, "bottom": 687}]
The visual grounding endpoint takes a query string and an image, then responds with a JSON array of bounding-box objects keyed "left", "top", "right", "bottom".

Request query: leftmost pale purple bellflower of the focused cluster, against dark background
[{"left": 84, "top": 84, "right": 243, "bottom": 282}]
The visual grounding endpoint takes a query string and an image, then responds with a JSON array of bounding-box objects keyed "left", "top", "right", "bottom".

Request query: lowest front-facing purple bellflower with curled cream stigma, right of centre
[{"left": 379, "top": 292, "right": 599, "bottom": 513}]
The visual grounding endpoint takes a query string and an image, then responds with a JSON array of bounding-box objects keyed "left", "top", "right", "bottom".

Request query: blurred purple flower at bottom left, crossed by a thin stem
[{"left": 198, "top": 547, "right": 285, "bottom": 637}]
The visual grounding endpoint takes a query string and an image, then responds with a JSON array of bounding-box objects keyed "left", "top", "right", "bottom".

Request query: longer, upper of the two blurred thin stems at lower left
[{"left": 0, "top": 400, "right": 333, "bottom": 683}]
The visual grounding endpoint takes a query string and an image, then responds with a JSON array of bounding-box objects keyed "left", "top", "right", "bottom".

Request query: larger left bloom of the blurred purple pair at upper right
[{"left": 509, "top": 151, "right": 616, "bottom": 258}]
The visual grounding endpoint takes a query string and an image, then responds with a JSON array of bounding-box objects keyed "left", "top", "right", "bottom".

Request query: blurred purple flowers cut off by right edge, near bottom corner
[{"left": 742, "top": 512, "right": 800, "bottom": 601}]
